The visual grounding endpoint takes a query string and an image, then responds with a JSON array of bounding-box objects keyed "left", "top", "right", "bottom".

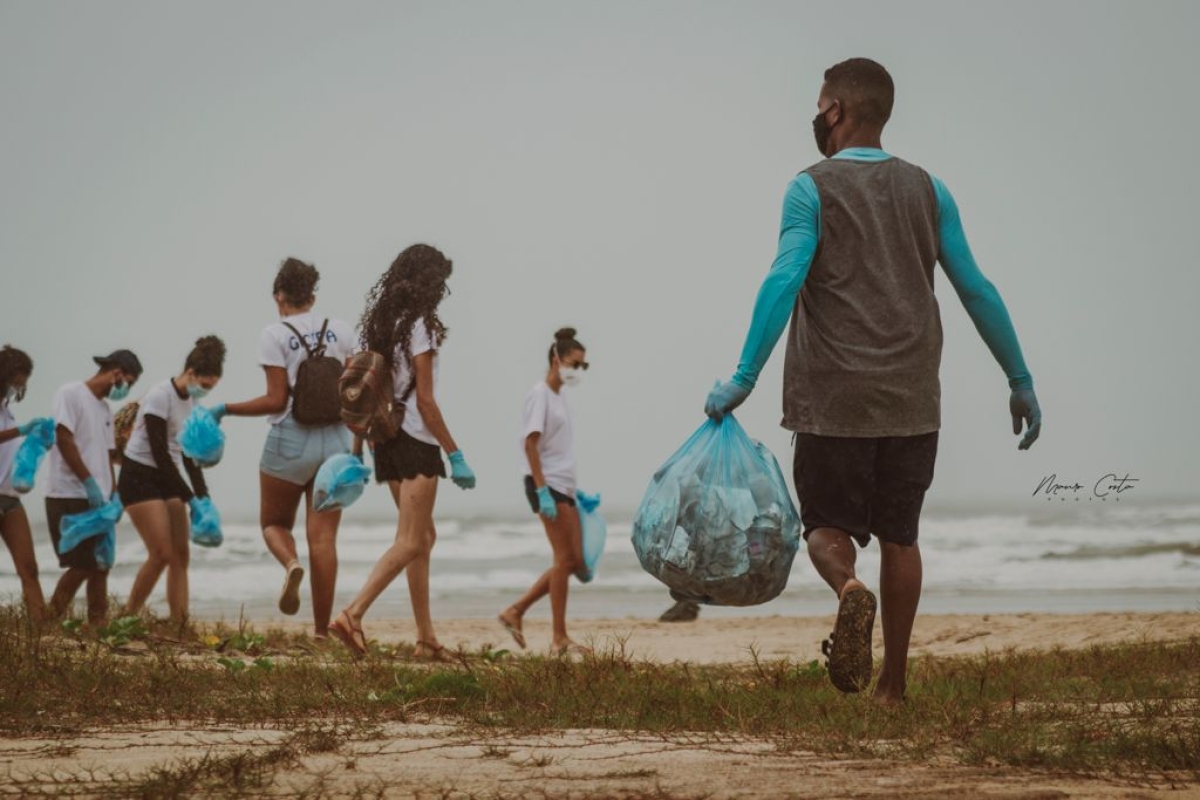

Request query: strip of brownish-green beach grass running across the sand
[{"left": 0, "top": 607, "right": 1200, "bottom": 795}]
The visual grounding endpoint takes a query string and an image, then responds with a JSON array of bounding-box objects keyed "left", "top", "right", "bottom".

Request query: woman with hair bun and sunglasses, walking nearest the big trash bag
[{"left": 499, "top": 327, "right": 589, "bottom": 655}]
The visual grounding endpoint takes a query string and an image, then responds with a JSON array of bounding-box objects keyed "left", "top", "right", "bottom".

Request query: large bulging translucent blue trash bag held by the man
[{"left": 632, "top": 415, "right": 800, "bottom": 606}]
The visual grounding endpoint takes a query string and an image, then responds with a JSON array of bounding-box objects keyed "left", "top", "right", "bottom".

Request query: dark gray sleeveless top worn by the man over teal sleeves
[{"left": 784, "top": 158, "right": 942, "bottom": 437}]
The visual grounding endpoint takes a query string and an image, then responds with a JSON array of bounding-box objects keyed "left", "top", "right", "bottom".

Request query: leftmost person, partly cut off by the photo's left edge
[{"left": 0, "top": 344, "right": 47, "bottom": 622}]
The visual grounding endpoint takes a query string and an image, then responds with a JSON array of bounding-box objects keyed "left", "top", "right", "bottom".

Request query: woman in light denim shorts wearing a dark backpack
[{"left": 212, "top": 258, "right": 355, "bottom": 637}]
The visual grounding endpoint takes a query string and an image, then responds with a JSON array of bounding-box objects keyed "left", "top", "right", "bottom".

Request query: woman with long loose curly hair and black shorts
[{"left": 329, "top": 245, "right": 475, "bottom": 661}]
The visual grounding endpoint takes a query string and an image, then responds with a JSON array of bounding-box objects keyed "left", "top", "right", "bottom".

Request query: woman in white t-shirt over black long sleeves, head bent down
[{"left": 116, "top": 336, "right": 226, "bottom": 624}]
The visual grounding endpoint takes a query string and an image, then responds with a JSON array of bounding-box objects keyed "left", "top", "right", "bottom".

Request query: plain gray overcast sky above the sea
[{"left": 0, "top": 0, "right": 1200, "bottom": 518}]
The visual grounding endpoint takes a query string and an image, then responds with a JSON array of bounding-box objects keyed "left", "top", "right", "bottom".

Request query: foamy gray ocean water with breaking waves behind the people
[{"left": 0, "top": 503, "right": 1200, "bottom": 620}]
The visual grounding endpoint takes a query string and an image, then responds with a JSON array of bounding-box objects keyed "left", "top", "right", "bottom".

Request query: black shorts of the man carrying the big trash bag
[{"left": 793, "top": 431, "right": 937, "bottom": 547}]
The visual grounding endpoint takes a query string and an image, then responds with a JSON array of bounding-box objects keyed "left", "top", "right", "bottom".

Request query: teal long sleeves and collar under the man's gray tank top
[{"left": 733, "top": 148, "right": 1033, "bottom": 390}]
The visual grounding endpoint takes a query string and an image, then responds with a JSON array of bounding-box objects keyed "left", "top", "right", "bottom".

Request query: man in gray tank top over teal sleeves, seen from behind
[{"left": 704, "top": 59, "right": 1042, "bottom": 703}]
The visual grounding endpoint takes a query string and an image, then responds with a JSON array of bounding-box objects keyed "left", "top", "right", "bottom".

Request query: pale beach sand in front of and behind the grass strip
[{"left": 0, "top": 613, "right": 1200, "bottom": 800}]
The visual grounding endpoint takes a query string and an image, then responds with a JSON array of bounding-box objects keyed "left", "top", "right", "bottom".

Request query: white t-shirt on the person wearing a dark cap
[{"left": 46, "top": 383, "right": 116, "bottom": 499}]
